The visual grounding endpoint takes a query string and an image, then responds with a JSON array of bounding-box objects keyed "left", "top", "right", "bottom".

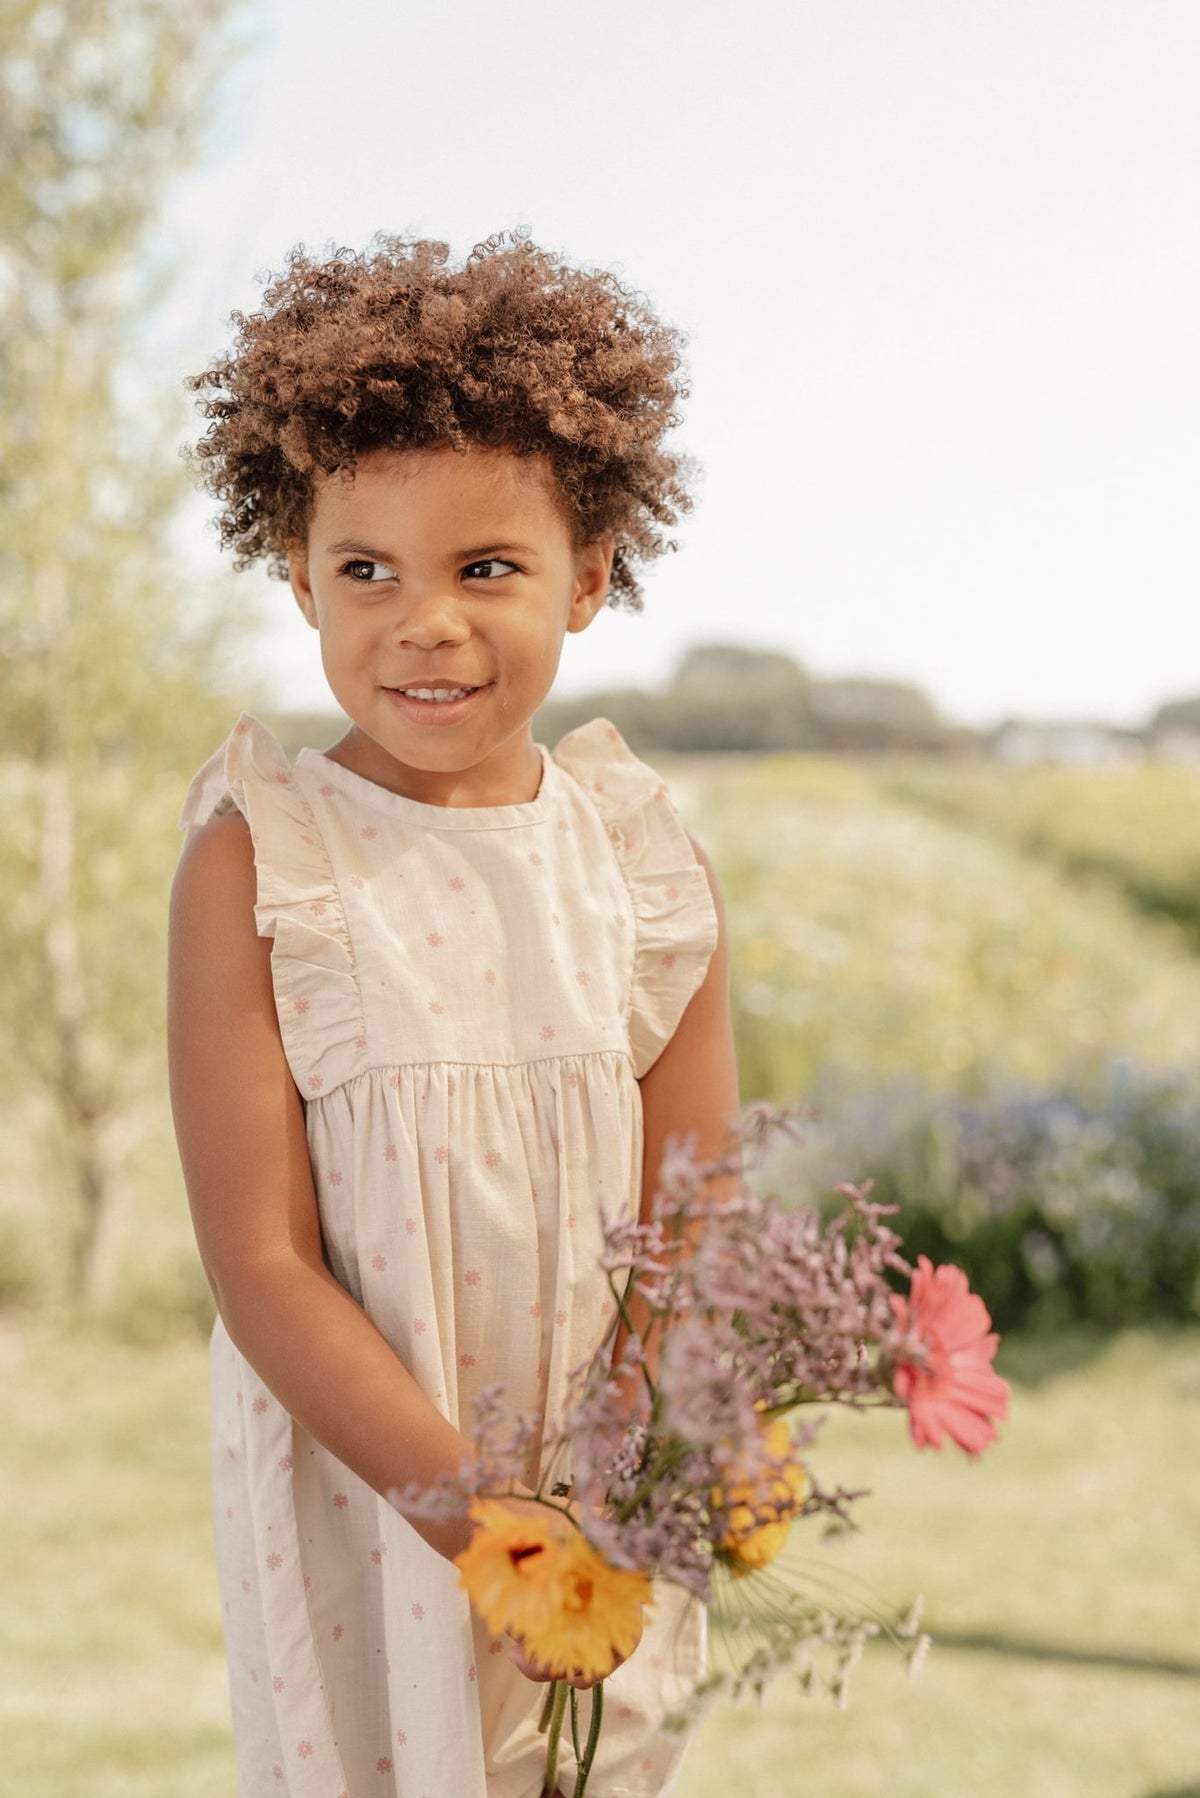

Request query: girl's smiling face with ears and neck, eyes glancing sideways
[{"left": 288, "top": 446, "right": 612, "bottom": 806}]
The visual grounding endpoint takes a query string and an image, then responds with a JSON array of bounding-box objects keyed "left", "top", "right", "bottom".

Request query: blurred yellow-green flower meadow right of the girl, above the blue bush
[{"left": 678, "top": 757, "right": 1200, "bottom": 1099}]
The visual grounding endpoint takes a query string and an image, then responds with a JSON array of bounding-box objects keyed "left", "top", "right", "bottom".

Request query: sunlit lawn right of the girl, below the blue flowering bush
[{"left": 680, "top": 1334, "right": 1200, "bottom": 1798}]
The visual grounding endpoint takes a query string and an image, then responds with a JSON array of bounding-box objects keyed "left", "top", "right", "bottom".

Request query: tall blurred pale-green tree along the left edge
[{"left": 0, "top": 0, "right": 248, "bottom": 1304}]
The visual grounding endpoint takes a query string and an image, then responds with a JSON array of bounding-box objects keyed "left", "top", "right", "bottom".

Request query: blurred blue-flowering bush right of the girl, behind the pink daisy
[{"left": 770, "top": 1064, "right": 1200, "bottom": 1331}]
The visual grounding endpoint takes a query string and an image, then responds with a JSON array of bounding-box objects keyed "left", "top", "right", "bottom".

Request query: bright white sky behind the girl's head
[{"left": 173, "top": 0, "right": 1200, "bottom": 723}]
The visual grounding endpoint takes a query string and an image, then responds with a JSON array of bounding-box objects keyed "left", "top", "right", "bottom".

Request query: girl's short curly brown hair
[{"left": 187, "top": 232, "right": 691, "bottom": 610}]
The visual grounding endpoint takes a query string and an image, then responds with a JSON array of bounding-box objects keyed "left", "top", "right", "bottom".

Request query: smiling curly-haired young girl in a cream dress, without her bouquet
[{"left": 169, "top": 239, "right": 736, "bottom": 1798}]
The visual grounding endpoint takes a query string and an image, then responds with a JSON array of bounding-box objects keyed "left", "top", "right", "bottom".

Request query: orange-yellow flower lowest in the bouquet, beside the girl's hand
[{"left": 455, "top": 1498, "right": 651, "bottom": 1679}]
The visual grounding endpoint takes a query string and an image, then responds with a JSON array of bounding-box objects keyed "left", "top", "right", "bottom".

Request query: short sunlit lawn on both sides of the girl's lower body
[{"left": 0, "top": 1318, "right": 1200, "bottom": 1798}]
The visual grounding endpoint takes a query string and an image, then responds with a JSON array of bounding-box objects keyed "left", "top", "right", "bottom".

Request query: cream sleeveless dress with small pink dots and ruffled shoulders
[{"left": 184, "top": 717, "right": 716, "bottom": 1798}]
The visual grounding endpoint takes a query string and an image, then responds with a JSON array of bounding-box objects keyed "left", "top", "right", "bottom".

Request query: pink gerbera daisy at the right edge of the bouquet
[{"left": 892, "top": 1255, "right": 1009, "bottom": 1455}]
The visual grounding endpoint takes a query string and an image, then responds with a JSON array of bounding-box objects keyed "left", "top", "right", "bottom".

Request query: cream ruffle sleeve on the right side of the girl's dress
[{"left": 554, "top": 717, "right": 718, "bottom": 1079}]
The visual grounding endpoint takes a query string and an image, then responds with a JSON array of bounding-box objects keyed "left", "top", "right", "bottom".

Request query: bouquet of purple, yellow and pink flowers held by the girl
[{"left": 396, "top": 1108, "right": 1009, "bottom": 1798}]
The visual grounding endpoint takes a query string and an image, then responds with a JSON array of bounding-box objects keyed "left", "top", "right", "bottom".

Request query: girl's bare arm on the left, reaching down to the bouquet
[{"left": 167, "top": 813, "right": 471, "bottom": 1557}]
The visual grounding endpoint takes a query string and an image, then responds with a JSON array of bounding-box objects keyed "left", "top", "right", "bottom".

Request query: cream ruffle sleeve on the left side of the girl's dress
[{"left": 180, "top": 714, "right": 367, "bottom": 1099}]
